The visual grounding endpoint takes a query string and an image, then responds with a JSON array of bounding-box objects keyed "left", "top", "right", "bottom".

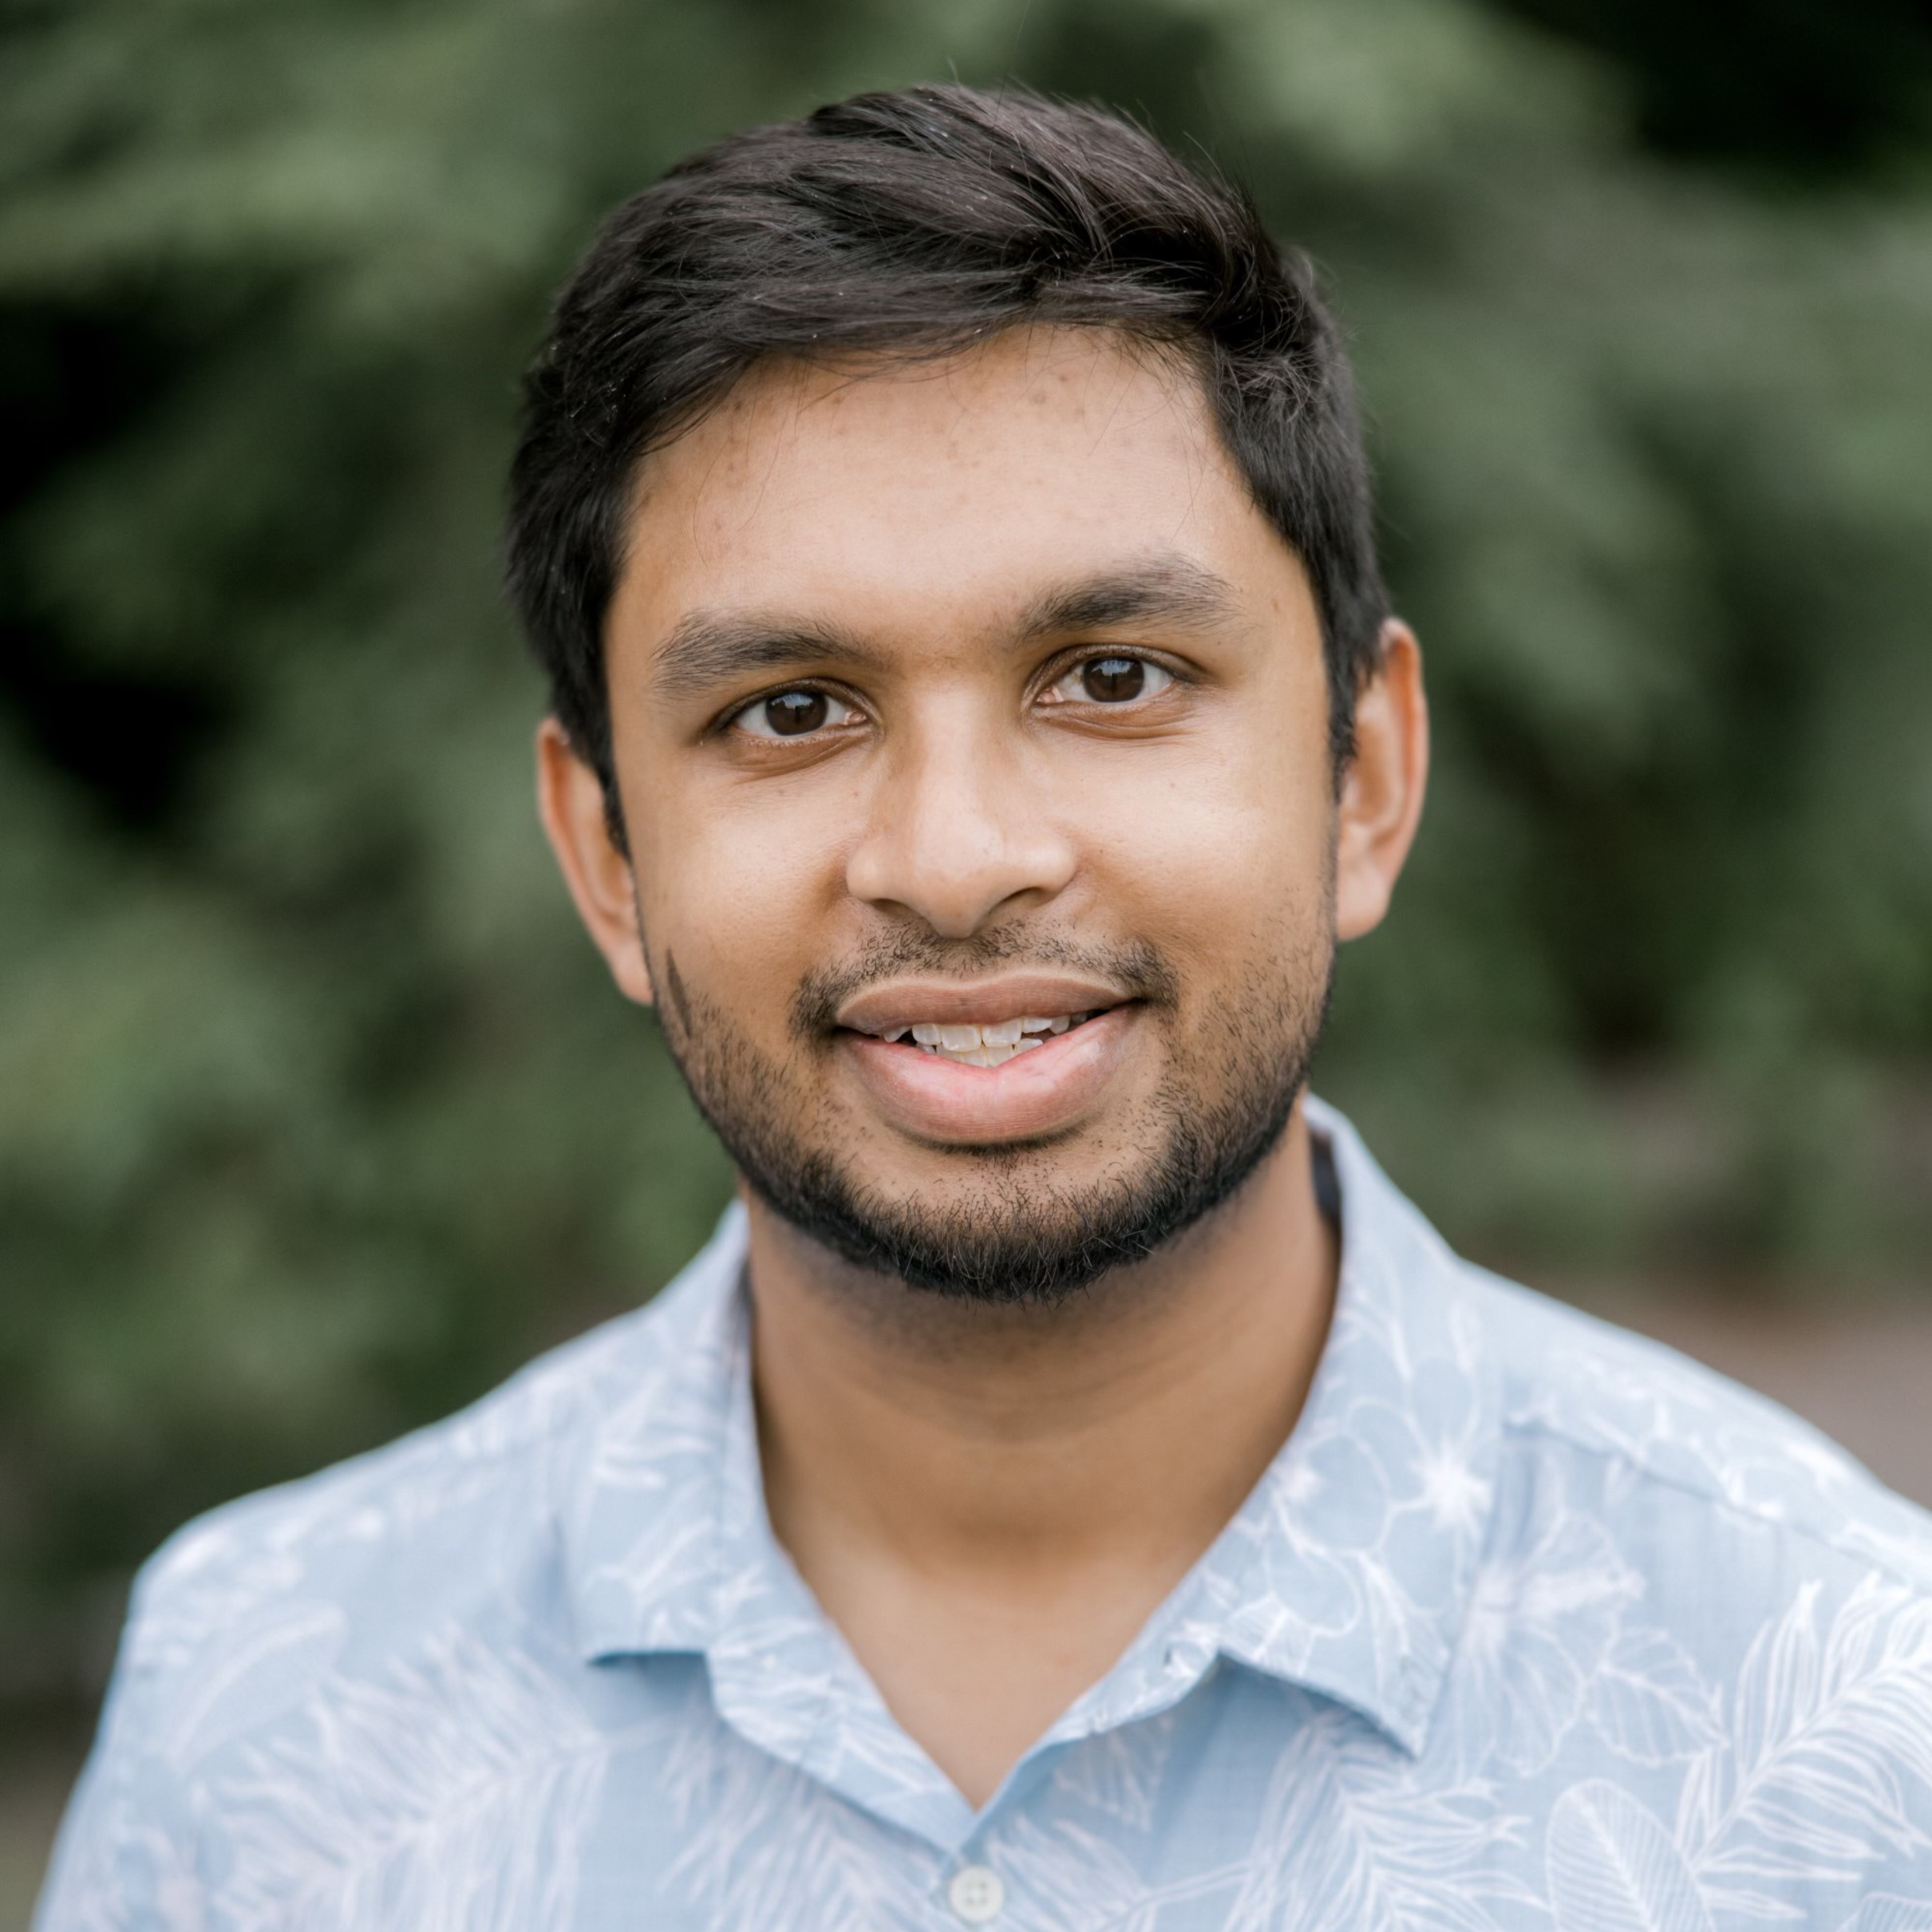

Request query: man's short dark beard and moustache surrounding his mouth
[{"left": 659, "top": 916, "right": 1335, "bottom": 1306}]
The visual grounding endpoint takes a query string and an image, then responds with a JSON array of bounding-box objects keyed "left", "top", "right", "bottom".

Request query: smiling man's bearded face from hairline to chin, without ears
[{"left": 560, "top": 330, "right": 1376, "bottom": 1298}]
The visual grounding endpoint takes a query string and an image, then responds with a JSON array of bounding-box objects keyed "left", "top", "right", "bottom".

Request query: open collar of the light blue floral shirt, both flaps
[{"left": 558, "top": 1099, "right": 1501, "bottom": 1772}]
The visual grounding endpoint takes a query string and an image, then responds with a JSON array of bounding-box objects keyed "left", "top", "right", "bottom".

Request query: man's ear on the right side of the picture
[{"left": 1335, "top": 618, "right": 1430, "bottom": 939}]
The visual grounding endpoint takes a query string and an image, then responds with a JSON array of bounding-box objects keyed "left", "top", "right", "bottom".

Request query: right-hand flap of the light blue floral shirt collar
[{"left": 1062, "top": 1099, "right": 1501, "bottom": 1752}]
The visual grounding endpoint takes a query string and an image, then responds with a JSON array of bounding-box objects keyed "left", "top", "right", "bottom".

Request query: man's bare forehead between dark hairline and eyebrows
[{"left": 611, "top": 329, "right": 1306, "bottom": 653}]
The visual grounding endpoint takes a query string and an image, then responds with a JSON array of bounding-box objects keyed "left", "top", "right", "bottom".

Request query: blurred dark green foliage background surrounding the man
[{"left": 0, "top": 0, "right": 1932, "bottom": 1922}]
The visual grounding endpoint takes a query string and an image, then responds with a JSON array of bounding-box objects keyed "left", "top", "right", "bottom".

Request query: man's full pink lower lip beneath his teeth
[{"left": 839, "top": 1005, "right": 1140, "bottom": 1145}]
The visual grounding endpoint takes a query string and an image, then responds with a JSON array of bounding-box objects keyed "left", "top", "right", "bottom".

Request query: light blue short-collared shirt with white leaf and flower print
[{"left": 39, "top": 1107, "right": 1932, "bottom": 1932}]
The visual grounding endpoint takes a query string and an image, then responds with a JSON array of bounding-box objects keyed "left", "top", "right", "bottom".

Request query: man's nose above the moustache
[{"left": 846, "top": 713, "right": 1076, "bottom": 939}]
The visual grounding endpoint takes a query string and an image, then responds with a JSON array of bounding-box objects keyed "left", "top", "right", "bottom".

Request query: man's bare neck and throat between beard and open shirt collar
[{"left": 752, "top": 1115, "right": 1335, "bottom": 1807}]
